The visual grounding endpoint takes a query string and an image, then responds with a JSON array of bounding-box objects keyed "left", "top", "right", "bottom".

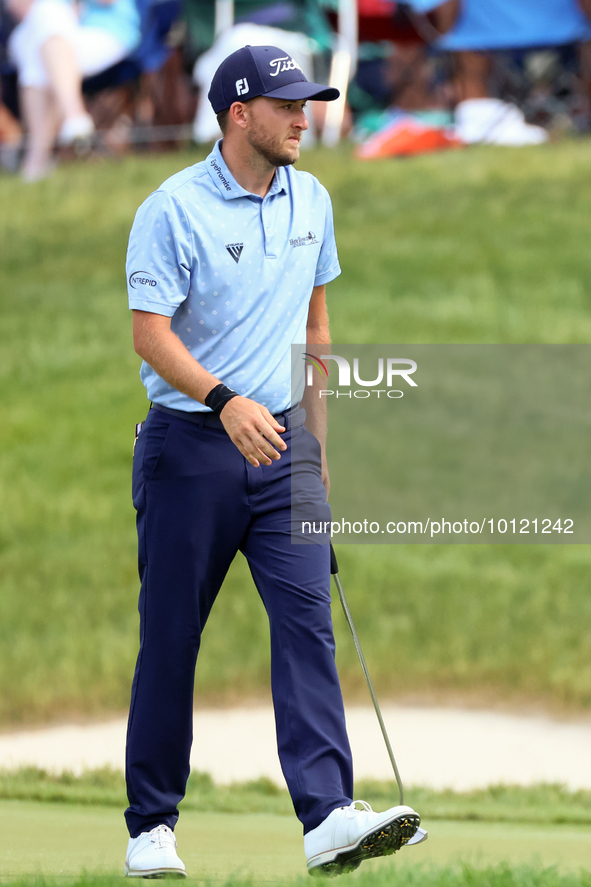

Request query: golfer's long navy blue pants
[{"left": 125, "top": 409, "right": 353, "bottom": 837}]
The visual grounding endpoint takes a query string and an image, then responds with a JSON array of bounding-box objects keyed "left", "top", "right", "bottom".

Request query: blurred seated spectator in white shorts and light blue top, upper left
[{"left": 7, "top": 0, "right": 140, "bottom": 181}]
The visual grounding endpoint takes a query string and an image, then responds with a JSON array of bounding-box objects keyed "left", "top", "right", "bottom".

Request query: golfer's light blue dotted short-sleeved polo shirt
[{"left": 127, "top": 141, "right": 341, "bottom": 413}]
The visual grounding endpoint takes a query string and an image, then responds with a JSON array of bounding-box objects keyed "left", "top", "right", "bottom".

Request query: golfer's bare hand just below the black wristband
[{"left": 220, "top": 396, "right": 287, "bottom": 468}]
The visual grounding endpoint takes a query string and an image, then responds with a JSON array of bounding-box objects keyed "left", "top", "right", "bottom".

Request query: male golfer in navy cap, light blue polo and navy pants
[{"left": 125, "top": 46, "right": 420, "bottom": 877}]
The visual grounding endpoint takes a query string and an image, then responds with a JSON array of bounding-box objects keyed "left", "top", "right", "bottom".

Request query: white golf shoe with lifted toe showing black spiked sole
[{"left": 304, "top": 801, "right": 427, "bottom": 876}]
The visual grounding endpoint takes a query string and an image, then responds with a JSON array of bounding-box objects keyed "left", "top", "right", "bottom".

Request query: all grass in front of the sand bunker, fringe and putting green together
[{"left": 0, "top": 769, "right": 591, "bottom": 887}]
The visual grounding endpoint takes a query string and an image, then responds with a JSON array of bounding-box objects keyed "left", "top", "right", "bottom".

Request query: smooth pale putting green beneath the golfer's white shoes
[{"left": 0, "top": 801, "right": 591, "bottom": 887}]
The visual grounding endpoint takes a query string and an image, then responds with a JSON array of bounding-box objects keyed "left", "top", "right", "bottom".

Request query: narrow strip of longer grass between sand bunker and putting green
[{"left": 0, "top": 767, "right": 591, "bottom": 826}]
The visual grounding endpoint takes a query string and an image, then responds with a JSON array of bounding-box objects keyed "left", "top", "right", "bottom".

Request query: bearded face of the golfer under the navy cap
[{"left": 245, "top": 96, "right": 308, "bottom": 166}]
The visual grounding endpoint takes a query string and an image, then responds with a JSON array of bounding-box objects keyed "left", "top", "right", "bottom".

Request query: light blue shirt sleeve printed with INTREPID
[{"left": 126, "top": 191, "right": 193, "bottom": 317}]
